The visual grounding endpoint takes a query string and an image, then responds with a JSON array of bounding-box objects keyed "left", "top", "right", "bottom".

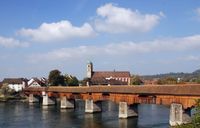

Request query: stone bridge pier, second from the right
[{"left": 119, "top": 102, "right": 138, "bottom": 118}]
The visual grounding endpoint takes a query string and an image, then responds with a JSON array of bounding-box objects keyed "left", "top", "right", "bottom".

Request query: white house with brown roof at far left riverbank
[{"left": 2, "top": 78, "right": 28, "bottom": 92}]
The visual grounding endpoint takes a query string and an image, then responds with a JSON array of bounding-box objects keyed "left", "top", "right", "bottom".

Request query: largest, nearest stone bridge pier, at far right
[{"left": 169, "top": 103, "right": 192, "bottom": 126}]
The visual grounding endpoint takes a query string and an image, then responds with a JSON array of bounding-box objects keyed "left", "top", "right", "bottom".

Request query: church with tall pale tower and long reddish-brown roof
[{"left": 87, "top": 62, "right": 131, "bottom": 85}]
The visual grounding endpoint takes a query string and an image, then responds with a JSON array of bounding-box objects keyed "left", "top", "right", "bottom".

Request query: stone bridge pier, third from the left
[{"left": 60, "top": 97, "right": 74, "bottom": 108}]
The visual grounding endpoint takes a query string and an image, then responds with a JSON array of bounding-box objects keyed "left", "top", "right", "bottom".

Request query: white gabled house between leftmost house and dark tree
[{"left": 27, "top": 78, "right": 47, "bottom": 87}]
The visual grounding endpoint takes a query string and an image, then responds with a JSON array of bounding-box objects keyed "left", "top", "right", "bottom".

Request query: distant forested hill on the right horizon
[{"left": 141, "top": 69, "right": 200, "bottom": 81}]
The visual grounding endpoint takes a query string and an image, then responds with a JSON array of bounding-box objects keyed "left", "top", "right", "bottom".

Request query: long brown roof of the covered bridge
[{"left": 25, "top": 84, "right": 200, "bottom": 96}]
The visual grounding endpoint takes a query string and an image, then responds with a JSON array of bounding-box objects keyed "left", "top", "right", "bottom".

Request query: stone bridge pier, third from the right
[{"left": 85, "top": 99, "right": 101, "bottom": 113}]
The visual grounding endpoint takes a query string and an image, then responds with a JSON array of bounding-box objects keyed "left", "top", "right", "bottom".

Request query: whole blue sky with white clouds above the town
[{"left": 0, "top": 0, "right": 200, "bottom": 79}]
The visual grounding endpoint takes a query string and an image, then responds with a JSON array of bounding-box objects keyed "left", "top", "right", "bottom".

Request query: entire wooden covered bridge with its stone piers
[{"left": 24, "top": 84, "right": 200, "bottom": 125}]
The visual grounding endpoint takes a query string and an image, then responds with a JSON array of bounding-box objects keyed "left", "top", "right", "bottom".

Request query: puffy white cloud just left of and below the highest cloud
[{"left": 18, "top": 20, "right": 95, "bottom": 42}]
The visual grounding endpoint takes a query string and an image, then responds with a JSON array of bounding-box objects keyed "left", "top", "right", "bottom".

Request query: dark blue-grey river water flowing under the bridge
[{"left": 0, "top": 100, "right": 169, "bottom": 128}]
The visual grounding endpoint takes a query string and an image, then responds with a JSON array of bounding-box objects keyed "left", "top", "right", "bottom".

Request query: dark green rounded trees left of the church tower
[{"left": 49, "top": 69, "right": 79, "bottom": 86}]
